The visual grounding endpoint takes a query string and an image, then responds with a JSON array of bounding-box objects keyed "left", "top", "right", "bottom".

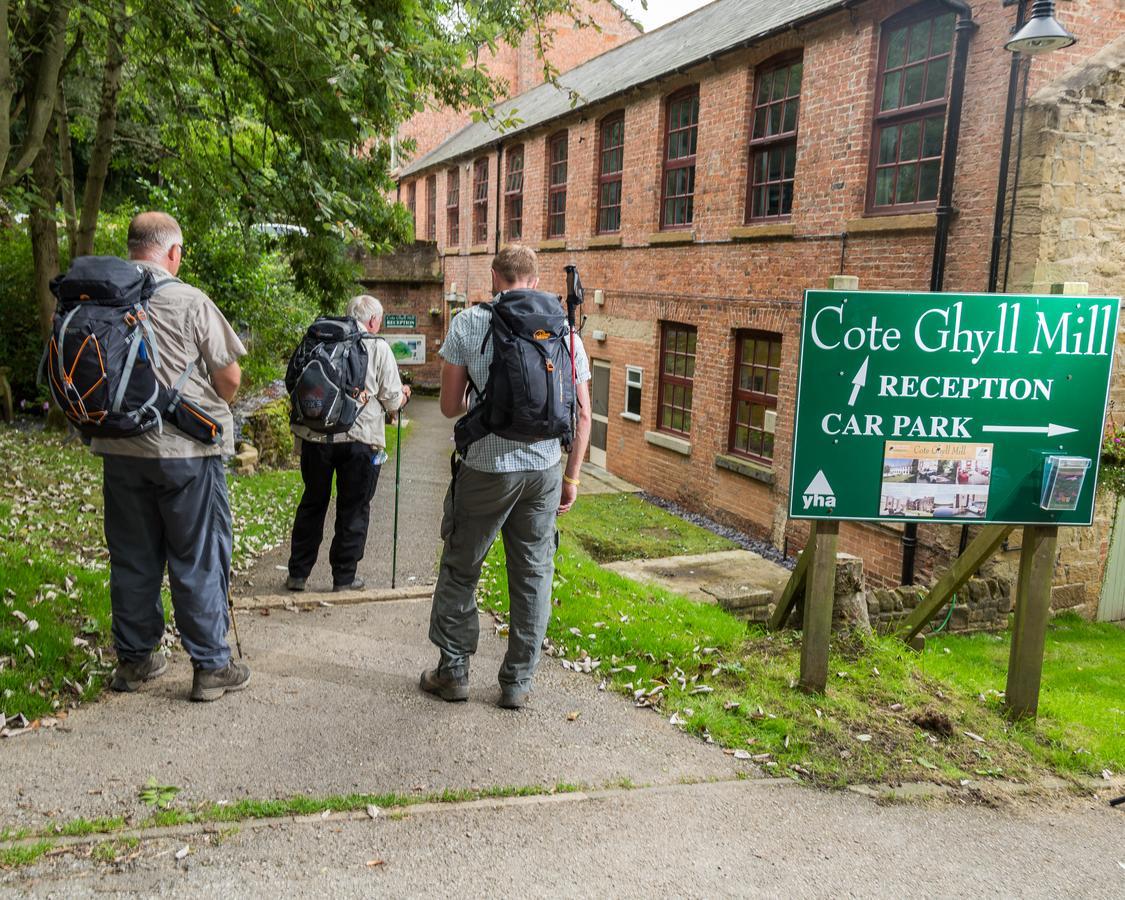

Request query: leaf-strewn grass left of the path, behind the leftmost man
[{"left": 0, "top": 425, "right": 300, "bottom": 720}]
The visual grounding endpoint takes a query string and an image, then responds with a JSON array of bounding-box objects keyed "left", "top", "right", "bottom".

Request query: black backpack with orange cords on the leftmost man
[{"left": 41, "top": 257, "right": 223, "bottom": 443}]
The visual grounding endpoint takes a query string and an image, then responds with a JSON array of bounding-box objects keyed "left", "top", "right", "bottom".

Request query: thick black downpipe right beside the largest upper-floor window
[{"left": 902, "top": 0, "right": 978, "bottom": 585}]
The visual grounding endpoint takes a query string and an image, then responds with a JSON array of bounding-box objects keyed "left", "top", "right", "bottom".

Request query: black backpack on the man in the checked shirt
[{"left": 453, "top": 289, "right": 575, "bottom": 456}]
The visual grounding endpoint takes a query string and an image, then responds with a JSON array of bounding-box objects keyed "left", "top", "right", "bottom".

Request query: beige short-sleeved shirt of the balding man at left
[{"left": 90, "top": 260, "right": 246, "bottom": 459}]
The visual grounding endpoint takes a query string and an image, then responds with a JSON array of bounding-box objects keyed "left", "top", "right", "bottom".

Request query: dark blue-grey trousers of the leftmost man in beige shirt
[{"left": 102, "top": 456, "right": 232, "bottom": 669}]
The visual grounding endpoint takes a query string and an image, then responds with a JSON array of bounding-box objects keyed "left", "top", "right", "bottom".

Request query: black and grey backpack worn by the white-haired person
[{"left": 285, "top": 316, "right": 376, "bottom": 434}]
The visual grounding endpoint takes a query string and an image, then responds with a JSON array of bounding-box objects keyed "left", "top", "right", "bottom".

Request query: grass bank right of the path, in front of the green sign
[{"left": 480, "top": 497, "right": 1125, "bottom": 785}]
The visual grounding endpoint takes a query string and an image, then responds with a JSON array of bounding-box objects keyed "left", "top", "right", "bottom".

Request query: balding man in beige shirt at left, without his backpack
[{"left": 90, "top": 213, "right": 250, "bottom": 701}]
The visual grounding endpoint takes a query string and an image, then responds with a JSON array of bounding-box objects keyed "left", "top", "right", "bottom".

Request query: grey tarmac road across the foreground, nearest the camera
[{"left": 8, "top": 782, "right": 1125, "bottom": 898}]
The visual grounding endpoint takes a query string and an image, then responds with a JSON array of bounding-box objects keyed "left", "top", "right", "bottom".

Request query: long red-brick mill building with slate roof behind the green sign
[{"left": 391, "top": 0, "right": 1125, "bottom": 612}]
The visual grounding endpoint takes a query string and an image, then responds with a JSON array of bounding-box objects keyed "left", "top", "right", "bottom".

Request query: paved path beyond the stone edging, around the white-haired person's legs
[{"left": 234, "top": 397, "right": 453, "bottom": 594}]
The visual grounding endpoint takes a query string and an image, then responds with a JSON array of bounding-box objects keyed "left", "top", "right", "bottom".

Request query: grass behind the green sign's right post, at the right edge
[{"left": 923, "top": 614, "right": 1125, "bottom": 773}]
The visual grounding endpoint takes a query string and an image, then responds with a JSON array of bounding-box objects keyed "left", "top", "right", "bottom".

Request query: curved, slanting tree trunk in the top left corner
[{"left": 0, "top": 0, "right": 74, "bottom": 188}]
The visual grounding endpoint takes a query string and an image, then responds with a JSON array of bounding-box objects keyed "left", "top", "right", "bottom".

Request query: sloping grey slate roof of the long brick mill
[{"left": 402, "top": 0, "right": 856, "bottom": 177}]
